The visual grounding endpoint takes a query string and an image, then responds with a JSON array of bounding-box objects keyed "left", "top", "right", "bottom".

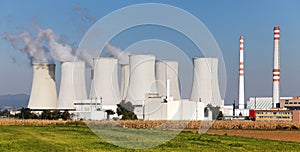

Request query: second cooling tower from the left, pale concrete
[{"left": 57, "top": 62, "right": 87, "bottom": 109}]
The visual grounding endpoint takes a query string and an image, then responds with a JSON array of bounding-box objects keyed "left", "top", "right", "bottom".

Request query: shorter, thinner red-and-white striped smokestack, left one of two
[{"left": 239, "top": 36, "right": 245, "bottom": 109}]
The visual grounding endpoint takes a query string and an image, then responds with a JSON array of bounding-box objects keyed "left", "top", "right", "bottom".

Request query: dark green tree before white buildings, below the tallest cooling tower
[{"left": 117, "top": 100, "right": 137, "bottom": 120}]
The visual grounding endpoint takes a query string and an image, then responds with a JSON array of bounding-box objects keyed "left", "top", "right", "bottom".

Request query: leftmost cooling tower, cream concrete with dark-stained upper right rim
[{"left": 28, "top": 64, "right": 57, "bottom": 110}]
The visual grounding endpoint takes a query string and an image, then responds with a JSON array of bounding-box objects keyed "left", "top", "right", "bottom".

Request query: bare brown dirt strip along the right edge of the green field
[{"left": 206, "top": 130, "right": 300, "bottom": 142}]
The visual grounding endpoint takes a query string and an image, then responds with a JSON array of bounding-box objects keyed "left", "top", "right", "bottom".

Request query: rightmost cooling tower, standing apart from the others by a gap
[{"left": 190, "top": 58, "right": 221, "bottom": 106}]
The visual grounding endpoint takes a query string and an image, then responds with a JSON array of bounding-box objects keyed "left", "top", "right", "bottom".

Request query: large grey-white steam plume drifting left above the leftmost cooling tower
[{"left": 3, "top": 28, "right": 75, "bottom": 63}]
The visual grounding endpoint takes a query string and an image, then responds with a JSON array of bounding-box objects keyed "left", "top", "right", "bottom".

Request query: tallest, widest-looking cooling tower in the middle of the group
[{"left": 126, "top": 55, "right": 156, "bottom": 105}]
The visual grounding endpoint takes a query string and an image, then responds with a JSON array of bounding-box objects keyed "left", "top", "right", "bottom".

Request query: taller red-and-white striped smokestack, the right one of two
[{"left": 273, "top": 26, "right": 280, "bottom": 108}]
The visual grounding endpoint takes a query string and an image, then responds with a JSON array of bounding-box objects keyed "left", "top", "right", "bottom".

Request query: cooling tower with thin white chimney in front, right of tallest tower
[{"left": 155, "top": 61, "right": 180, "bottom": 100}]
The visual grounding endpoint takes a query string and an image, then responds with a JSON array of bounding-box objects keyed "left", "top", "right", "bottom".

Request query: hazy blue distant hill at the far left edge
[{"left": 0, "top": 94, "right": 29, "bottom": 110}]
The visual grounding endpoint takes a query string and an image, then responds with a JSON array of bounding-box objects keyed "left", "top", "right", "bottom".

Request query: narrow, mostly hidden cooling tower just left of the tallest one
[{"left": 120, "top": 64, "right": 130, "bottom": 100}]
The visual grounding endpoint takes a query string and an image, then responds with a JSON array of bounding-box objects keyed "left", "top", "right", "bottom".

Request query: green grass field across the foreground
[{"left": 0, "top": 126, "right": 300, "bottom": 152}]
